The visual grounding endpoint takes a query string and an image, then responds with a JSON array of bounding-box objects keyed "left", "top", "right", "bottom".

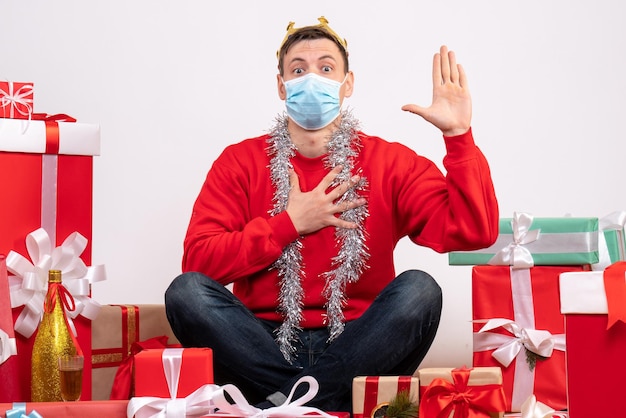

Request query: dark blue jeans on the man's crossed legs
[{"left": 165, "top": 270, "right": 442, "bottom": 412}]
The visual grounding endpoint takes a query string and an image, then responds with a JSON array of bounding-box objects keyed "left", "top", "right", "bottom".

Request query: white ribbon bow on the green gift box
[{"left": 488, "top": 212, "right": 540, "bottom": 268}]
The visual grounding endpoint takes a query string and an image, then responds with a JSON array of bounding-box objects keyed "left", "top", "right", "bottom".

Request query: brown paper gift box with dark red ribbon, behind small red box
[{"left": 91, "top": 304, "right": 178, "bottom": 400}]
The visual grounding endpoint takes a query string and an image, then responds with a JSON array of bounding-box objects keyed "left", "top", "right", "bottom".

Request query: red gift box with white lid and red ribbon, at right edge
[{"left": 560, "top": 262, "right": 626, "bottom": 418}]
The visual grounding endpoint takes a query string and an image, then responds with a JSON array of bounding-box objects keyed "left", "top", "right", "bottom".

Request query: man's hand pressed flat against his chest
[{"left": 287, "top": 166, "right": 365, "bottom": 235}]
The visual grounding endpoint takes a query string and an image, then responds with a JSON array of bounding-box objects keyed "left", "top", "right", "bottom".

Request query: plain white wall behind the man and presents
[{"left": 0, "top": 0, "right": 626, "bottom": 366}]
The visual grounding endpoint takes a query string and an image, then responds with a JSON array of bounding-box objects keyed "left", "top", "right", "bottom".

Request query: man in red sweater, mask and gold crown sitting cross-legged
[{"left": 165, "top": 18, "right": 498, "bottom": 411}]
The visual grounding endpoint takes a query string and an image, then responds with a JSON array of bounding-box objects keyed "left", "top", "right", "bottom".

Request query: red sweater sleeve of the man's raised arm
[{"left": 399, "top": 129, "right": 499, "bottom": 253}]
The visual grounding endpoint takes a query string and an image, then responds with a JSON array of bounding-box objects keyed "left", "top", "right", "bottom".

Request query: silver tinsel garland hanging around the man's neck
[{"left": 268, "top": 111, "right": 369, "bottom": 362}]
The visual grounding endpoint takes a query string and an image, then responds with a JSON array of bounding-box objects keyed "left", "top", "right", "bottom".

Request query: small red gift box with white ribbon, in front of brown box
[{"left": 135, "top": 348, "right": 213, "bottom": 398}]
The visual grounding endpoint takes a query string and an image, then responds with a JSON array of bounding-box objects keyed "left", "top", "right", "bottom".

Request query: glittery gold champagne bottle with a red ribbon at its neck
[{"left": 30, "top": 270, "right": 80, "bottom": 402}]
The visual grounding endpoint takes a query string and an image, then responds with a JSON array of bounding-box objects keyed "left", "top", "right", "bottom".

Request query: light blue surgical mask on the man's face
[{"left": 283, "top": 73, "right": 348, "bottom": 131}]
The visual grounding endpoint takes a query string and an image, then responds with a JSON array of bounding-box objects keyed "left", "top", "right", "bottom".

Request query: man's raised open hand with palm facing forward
[{"left": 402, "top": 45, "right": 472, "bottom": 136}]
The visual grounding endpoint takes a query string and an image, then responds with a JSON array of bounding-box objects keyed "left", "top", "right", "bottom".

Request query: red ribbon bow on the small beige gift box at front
[{"left": 419, "top": 367, "right": 506, "bottom": 418}]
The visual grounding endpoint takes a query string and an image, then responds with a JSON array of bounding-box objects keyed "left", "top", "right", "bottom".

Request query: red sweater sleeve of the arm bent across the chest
[{"left": 182, "top": 144, "right": 298, "bottom": 284}]
